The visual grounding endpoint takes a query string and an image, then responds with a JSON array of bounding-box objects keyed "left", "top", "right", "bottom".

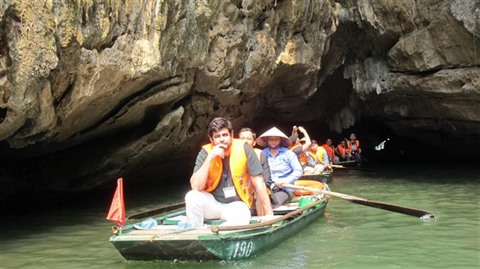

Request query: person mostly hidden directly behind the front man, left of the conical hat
[{"left": 238, "top": 128, "right": 275, "bottom": 216}]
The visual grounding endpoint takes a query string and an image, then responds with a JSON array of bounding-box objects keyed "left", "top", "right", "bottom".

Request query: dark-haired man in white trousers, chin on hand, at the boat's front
[{"left": 185, "top": 117, "right": 269, "bottom": 227}]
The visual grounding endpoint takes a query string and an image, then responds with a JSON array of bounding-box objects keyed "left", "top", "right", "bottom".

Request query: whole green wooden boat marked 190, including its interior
[{"left": 110, "top": 194, "right": 328, "bottom": 261}]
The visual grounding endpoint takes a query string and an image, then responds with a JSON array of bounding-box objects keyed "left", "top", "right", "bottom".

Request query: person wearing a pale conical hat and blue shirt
[{"left": 256, "top": 127, "right": 303, "bottom": 206}]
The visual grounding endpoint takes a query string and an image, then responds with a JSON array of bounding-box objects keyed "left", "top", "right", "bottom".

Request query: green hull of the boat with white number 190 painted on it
[{"left": 110, "top": 201, "right": 327, "bottom": 261}]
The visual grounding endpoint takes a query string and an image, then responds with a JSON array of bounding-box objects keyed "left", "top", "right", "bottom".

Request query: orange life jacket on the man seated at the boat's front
[{"left": 203, "top": 139, "right": 255, "bottom": 208}]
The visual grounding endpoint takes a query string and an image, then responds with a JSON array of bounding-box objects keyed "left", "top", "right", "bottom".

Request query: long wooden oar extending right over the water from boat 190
[{"left": 282, "top": 184, "right": 435, "bottom": 219}]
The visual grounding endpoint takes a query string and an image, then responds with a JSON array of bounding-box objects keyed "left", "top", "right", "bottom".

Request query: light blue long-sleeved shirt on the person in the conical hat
[{"left": 263, "top": 147, "right": 303, "bottom": 184}]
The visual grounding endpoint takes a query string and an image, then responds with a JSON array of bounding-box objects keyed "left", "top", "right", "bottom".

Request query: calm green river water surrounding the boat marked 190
[{"left": 0, "top": 162, "right": 480, "bottom": 269}]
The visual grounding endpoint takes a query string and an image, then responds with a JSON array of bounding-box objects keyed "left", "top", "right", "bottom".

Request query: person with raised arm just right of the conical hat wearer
[{"left": 289, "top": 126, "right": 314, "bottom": 174}]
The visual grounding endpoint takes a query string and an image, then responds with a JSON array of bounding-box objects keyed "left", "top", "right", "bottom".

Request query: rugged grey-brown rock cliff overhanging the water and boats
[{"left": 0, "top": 0, "right": 480, "bottom": 197}]
